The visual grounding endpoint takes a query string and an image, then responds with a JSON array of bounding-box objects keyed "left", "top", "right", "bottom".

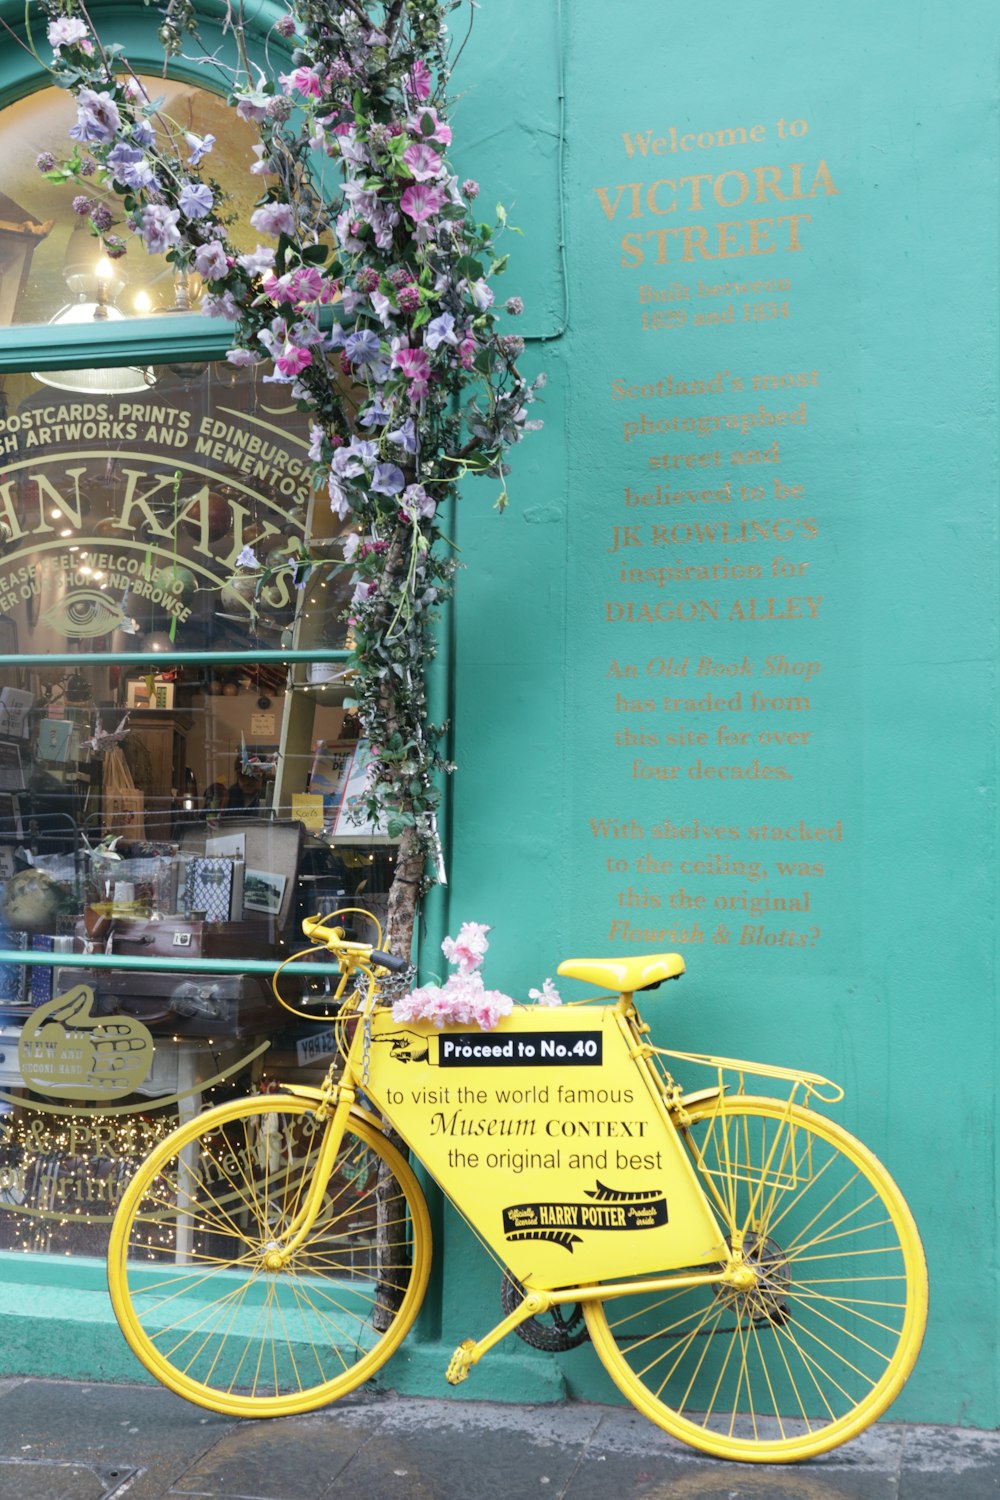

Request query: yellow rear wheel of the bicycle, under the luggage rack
[{"left": 586, "top": 1095, "right": 927, "bottom": 1463}]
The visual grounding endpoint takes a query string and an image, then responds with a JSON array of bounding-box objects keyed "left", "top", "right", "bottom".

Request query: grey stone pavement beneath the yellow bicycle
[{"left": 0, "top": 1379, "right": 1000, "bottom": 1500}]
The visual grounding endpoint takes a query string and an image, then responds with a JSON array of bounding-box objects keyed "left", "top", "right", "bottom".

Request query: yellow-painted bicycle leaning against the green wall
[{"left": 109, "top": 914, "right": 927, "bottom": 1463}]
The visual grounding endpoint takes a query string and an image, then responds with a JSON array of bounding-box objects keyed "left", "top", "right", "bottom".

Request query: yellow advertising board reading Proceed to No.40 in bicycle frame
[{"left": 366, "top": 1007, "right": 726, "bottom": 1289}]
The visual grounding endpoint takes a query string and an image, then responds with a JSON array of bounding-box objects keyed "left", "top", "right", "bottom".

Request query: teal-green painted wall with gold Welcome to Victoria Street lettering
[{"left": 444, "top": 0, "right": 1000, "bottom": 1427}]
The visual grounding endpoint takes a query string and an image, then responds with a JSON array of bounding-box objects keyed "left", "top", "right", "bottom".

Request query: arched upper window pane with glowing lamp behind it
[{"left": 0, "top": 78, "right": 259, "bottom": 327}]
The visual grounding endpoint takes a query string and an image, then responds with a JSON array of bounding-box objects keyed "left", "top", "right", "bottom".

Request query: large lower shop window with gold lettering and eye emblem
[{"left": 0, "top": 362, "right": 393, "bottom": 1254}]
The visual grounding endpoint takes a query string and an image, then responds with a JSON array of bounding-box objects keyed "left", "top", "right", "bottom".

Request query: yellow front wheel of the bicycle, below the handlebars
[{"left": 108, "top": 1094, "right": 430, "bottom": 1418}]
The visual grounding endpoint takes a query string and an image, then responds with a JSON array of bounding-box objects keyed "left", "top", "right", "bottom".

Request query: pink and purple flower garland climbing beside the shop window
[{"left": 31, "top": 0, "right": 543, "bottom": 950}]
